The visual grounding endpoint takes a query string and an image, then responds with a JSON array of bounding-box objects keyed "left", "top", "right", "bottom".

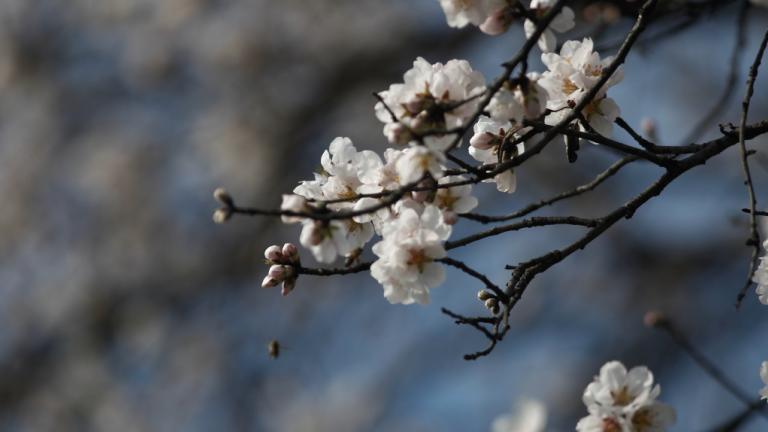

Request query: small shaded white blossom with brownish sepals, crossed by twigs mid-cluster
[{"left": 469, "top": 116, "right": 525, "bottom": 193}]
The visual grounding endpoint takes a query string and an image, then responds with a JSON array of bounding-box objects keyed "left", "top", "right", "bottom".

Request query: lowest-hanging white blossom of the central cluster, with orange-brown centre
[{"left": 371, "top": 204, "right": 451, "bottom": 304}]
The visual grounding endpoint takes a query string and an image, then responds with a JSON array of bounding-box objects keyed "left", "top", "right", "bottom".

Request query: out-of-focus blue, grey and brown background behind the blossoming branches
[{"left": 0, "top": 0, "right": 768, "bottom": 432}]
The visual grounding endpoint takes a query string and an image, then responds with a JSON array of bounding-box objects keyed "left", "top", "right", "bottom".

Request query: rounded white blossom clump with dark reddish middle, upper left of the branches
[{"left": 376, "top": 57, "right": 485, "bottom": 141}]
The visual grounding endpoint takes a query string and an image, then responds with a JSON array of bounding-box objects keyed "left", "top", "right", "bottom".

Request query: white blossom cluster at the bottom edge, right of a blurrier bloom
[{"left": 576, "top": 361, "right": 676, "bottom": 432}]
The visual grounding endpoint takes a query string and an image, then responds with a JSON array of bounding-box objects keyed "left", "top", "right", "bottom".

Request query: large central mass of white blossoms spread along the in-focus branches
[{"left": 258, "top": 5, "right": 622, "bottom": 304}]
